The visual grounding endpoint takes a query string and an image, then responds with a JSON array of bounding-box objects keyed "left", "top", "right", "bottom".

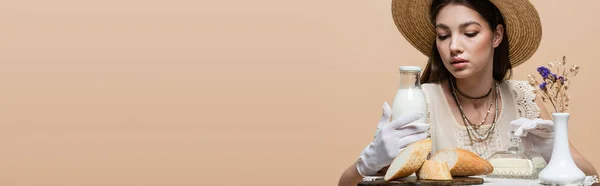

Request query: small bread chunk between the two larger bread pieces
[{"left": 417, "top": 160, "right": 452, "bottom": 180}]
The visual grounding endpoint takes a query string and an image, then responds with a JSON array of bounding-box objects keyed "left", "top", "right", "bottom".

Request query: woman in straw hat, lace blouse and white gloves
[{"left": 339, "top": 0, "right": 597, "bottom": 185}]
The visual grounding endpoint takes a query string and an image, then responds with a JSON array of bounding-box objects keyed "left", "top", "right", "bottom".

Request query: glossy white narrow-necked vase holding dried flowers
[{"left": 538, "top": 113, "right": 585, "bottom": 185}]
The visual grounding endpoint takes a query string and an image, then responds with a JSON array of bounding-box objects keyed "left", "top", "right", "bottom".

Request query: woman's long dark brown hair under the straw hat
[{"left": 421, "top": 0, "right": 512, "bottom": 83}]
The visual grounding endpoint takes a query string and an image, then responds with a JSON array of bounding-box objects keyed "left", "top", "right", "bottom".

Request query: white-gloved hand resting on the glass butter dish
[{"left": 510, "top": 118, "right": 554, "bottom": 139}]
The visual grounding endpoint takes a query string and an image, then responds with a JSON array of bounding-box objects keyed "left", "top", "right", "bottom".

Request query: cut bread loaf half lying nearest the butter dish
[{"left": 431, "top": 148, "right": 494, "bottom": 176}]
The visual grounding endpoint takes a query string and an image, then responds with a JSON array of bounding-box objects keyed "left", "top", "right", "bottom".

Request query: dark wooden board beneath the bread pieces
[{"left": 358, "top": 177, "right": 483, "bottom": 186}]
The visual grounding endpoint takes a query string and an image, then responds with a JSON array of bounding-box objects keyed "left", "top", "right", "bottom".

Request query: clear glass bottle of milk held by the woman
[{"left": 392, "top": 66, "right": 427, "bottom": 123}]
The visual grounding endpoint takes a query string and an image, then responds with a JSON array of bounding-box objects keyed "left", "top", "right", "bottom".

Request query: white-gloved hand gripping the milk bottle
[{"left": 356, "top": 102, "right": 429, "bottom": 177}]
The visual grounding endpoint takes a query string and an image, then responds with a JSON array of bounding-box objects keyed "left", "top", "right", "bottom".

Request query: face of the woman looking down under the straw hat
[{"left": 435, "top": 4, "right": 503, "bottom": 78}]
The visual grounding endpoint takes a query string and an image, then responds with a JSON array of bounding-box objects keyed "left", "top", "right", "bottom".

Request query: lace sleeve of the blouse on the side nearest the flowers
[{"left": 509, "top": 81, "right": 540, "bottom": 119}]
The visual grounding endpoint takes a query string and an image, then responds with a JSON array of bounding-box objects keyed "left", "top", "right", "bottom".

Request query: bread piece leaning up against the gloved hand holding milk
[{"left": 384, "top": 138, "right": 431, "bottom": 181}]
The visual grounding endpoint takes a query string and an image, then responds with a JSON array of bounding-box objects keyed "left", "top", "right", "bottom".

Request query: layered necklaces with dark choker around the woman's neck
[{"left": 450, "top": 80, "right": 500, "bottom": 147}]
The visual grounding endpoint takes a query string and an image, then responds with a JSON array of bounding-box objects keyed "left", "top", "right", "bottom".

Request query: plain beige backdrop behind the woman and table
[{"left": 0, "top": 0, "right": 600, "bottom": 186}]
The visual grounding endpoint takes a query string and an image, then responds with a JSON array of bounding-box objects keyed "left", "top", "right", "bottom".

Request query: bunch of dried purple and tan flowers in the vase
[{"left": 527, "top": 56, "right": 579, "bottom": 112}]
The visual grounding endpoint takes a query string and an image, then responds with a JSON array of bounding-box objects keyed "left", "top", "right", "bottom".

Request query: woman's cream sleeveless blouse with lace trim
[{"left": 422, "top": 80, "right": 552, "bottom": 162}]
